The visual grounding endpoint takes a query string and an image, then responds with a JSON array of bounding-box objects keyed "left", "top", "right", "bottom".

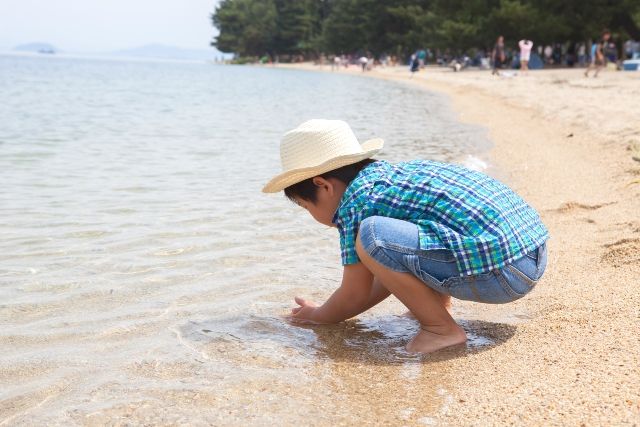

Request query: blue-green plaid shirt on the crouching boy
[{"left": 333, "top": 160, "right": 549, "bottom": 276}]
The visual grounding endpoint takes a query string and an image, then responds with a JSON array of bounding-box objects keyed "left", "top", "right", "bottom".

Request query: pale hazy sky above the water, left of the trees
[{"left": 0, "top": 0, "right": 219, "bottom": 52}]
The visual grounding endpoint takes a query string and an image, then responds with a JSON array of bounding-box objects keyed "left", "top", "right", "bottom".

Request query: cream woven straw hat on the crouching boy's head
[{"left": 262, "top": 119, "right": 383, "bottom": 193}]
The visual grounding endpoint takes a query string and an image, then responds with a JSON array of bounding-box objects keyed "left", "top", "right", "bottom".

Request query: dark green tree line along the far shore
[{"left": 212, "top": 0, "right": 640, "bottom": 59}]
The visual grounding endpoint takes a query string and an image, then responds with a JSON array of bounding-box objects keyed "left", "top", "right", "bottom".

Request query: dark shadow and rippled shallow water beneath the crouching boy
[{"left": 181, "top": 315, "right": 516, "bottom": 365}]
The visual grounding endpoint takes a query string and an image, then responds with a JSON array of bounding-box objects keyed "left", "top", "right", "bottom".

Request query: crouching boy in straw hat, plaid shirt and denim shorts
[{"left": 263, "top": 120, "right": 548, "bottom": 353}]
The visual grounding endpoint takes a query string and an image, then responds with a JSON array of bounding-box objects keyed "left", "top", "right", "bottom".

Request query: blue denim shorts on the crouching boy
[{"left": 359, "top": 216, "right": 547, "bottom": 304}]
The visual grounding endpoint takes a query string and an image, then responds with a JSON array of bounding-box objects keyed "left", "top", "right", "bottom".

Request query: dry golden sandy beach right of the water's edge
[{"left": 282, "top": 64, "right": 640, "bottom": 425}]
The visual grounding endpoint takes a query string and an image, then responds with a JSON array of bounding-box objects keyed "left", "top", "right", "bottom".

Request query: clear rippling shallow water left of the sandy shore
[{"left": 0, "top": 56, "right": 486, "bottom": 425}]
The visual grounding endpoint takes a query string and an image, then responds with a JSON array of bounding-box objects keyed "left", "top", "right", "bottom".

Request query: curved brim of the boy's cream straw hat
[{"left": 262, "top": 138, "right": 384, "bottom": 193}]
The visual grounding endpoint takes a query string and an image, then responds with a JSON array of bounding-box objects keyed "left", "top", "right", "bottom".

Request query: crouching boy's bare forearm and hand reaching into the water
[{"left": 291, "top": 263, "right": 389, "bottom": 323}]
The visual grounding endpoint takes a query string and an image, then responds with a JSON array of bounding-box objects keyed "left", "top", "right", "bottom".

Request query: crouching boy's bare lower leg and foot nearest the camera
[{"left": 356, "top": 237, "right": 467, "bottom": 353}]
